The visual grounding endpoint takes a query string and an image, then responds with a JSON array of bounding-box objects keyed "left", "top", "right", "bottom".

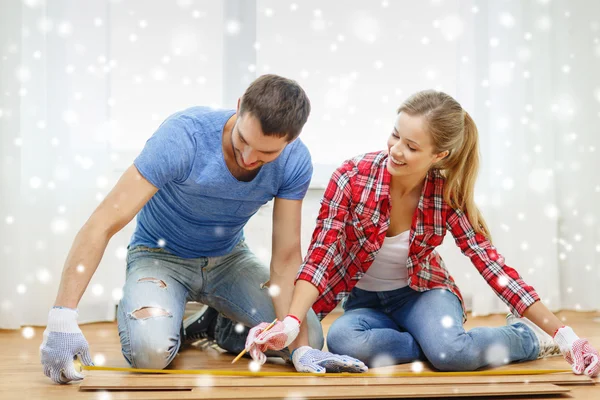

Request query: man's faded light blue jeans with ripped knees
[{"left": 117, "top": 240, "right": 324, "bottom": 369}]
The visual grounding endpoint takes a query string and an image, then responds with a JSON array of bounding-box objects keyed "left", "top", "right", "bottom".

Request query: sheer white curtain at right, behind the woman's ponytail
[{"left": 444, "top": 0, "right": 600, "bottom": 314}]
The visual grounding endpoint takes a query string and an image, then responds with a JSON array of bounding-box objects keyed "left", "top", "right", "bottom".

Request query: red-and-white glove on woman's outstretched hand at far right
[{"left": 554, "top": 326, "right": 600, "bottom": 377}]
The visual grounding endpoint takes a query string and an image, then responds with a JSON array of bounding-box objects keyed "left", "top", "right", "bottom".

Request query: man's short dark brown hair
[{"left": 240, "top": 74, "right": 310, "bottom": 142}]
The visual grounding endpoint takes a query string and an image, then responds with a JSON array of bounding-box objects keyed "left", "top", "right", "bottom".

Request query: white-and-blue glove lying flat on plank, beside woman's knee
[{"left": 292, "top": 346, "right": 369, "bottom": 374}]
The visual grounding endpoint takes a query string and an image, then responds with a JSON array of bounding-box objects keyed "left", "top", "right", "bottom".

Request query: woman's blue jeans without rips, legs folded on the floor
[{"left": 327, "top": 286, "right": 539, "bottom": 371}]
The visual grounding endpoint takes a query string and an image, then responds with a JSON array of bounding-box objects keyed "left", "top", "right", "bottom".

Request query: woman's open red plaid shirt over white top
[{"left": 297, "top": 152, "right": 539, "bottom": 320}]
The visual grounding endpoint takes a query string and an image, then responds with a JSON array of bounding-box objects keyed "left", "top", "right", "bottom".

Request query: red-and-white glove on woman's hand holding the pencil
[{"left": 246, "top": 315, "right": 300, "bottom": 365}]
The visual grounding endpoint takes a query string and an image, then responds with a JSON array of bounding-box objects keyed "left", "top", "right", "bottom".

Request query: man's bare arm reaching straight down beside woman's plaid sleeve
[{"left": 270, "top": 198, "right": 308, "bottom": 350}]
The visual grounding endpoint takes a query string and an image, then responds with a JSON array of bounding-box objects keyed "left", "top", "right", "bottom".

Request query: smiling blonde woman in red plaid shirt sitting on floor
[{"left": 246, "top": 91, "right": 600, "bottom": 376}]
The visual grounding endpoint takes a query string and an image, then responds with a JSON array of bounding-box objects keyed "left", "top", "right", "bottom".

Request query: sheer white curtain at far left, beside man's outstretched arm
[{"left": 0, "top": 1, "right": 118, "bottom": 328}]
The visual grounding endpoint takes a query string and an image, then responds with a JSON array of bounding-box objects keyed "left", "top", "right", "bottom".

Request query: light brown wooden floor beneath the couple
[{"left": 0, "top": 312, "right": 600, "bottom": 400}]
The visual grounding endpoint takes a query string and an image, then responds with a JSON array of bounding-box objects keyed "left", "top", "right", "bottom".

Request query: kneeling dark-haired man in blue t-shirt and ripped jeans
[{"left": 41, "top": 75, "right": 323, "bottom": 383}]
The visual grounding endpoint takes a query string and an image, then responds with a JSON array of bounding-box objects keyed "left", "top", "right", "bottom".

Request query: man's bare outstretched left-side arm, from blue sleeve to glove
[{"left": 54, "top": 165, "right": 158, "bottom": 308}]
